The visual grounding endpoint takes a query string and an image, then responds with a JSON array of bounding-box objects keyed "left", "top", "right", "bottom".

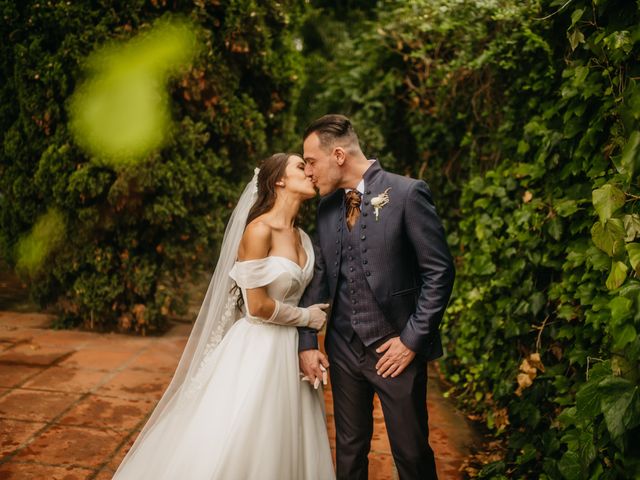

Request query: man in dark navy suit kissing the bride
[{"left": 299, "top": 115, "right": 454, "bottom": 480}]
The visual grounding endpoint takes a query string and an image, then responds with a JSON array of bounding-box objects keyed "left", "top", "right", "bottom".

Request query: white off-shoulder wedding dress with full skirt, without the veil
[{"left": 114, "top": 230, "right": 335, "bottom": 480}]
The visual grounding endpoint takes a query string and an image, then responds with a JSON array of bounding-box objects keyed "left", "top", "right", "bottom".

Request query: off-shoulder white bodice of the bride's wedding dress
[{"left": 229, "top": 229, "right": 315, "bottom": 317}]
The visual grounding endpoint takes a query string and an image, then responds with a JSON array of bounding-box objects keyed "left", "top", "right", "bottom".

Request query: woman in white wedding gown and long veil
[{"left": 114, "top": 153, "right": 335, "bottom": 480}]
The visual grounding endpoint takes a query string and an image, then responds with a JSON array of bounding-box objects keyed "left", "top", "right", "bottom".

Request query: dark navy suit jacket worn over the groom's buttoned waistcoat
[{"left": 299, "top": 161, "right": 455, "bottom": 360}]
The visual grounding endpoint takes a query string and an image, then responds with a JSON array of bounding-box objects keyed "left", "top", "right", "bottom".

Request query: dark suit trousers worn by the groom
[{"left": 325, "top": 328, "right": 437, "bottom": 480}]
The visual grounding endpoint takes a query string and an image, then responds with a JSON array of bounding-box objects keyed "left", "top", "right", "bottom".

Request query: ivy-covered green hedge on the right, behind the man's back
[{"left": 307, "top": 0, "right": 640, "bottom": 479}]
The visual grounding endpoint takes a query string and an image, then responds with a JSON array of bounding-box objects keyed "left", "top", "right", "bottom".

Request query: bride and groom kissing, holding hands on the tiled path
[{"left": 114, "top": 115, "right": 454, "bottom": 480}]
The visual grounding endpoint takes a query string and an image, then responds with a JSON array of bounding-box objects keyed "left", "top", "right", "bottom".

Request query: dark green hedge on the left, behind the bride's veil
[{"left": 0, "top": 0, "right": 302, "bottom": 333}]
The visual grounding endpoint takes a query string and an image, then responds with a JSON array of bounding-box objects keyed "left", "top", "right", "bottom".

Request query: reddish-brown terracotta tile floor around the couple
[{"left": 0, "top": 312, "right": 477, "bottom": 480}]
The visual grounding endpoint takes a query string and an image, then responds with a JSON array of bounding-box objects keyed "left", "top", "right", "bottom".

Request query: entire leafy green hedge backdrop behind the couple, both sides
[{"left": 0, "top": 0, "right": 640, "bottom": 480}]
